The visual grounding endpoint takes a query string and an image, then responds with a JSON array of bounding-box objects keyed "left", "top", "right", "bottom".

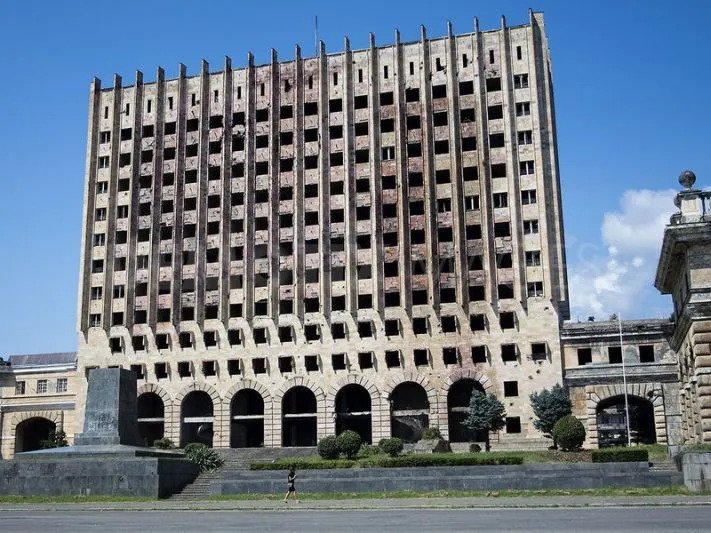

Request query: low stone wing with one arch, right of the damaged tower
[{"left": 561, "top": 320, "right": 681, "bottom": 447}]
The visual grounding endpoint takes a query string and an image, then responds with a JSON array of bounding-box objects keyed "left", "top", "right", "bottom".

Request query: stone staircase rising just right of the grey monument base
[{"left": 169, "top": 447, "right": 317, "bottom": 501}]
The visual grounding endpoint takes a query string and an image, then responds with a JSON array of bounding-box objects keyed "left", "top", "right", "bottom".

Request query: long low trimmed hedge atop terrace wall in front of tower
[{"left": 249, "top": 453, "right": 523, "bottom": 470}]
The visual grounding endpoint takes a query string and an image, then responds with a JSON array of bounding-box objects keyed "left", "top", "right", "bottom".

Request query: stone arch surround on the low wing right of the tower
[{"left": 585, "top": 382, "right": 667, "bottom": 446}]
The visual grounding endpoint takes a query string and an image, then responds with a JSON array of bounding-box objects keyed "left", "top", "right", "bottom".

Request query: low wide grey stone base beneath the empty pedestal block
[{"left": 0, "top": 457, "right": 198, "bottom": 498}]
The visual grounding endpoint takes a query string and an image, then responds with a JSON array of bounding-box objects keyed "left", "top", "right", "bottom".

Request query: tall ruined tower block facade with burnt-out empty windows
[{"left": 71, "top": 9, "right": 568, "bottom": 447}]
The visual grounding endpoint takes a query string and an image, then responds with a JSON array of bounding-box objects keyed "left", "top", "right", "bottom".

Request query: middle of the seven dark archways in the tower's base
[{"left": 281, "top": 385, "right": 316, "bottom": 446}]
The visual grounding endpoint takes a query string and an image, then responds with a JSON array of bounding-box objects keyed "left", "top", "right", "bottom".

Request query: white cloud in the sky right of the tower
[{"left": 567, "top": 189, "right": 676, "bottom": 320}]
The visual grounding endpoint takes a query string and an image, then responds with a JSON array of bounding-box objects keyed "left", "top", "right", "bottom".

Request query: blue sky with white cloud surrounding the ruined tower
[{"left": 0, "top": 0, "right": 711, "bottom": 356}]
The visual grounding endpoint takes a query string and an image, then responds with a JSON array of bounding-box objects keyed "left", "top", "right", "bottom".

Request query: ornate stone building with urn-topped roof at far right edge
[{"left": 654, "top": 170, "right": 711, "bottom": 444}]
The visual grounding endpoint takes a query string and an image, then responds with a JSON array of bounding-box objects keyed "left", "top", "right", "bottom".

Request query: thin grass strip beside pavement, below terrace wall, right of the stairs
[{"left": 208, "top": 485, "right": 690, "bottom": 501}]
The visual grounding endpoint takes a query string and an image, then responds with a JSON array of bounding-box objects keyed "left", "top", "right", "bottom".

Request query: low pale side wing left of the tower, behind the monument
[{"left": 0, "top": 352, "right": 77, "bottom": 459}]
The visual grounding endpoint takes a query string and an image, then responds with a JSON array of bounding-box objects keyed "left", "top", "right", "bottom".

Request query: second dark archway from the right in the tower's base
[{"left": 390, "top": 381, "right": 430, "bottom": 442}]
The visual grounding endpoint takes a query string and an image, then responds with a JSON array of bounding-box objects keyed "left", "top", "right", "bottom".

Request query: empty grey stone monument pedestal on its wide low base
[{"left": 0, "top": 368, "right": 198, "bottom": 498}]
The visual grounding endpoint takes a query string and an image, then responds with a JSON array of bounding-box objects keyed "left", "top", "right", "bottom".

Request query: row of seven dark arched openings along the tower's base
[{"left": 138, "top": 379, "right": 492, "bottom": 448}]
